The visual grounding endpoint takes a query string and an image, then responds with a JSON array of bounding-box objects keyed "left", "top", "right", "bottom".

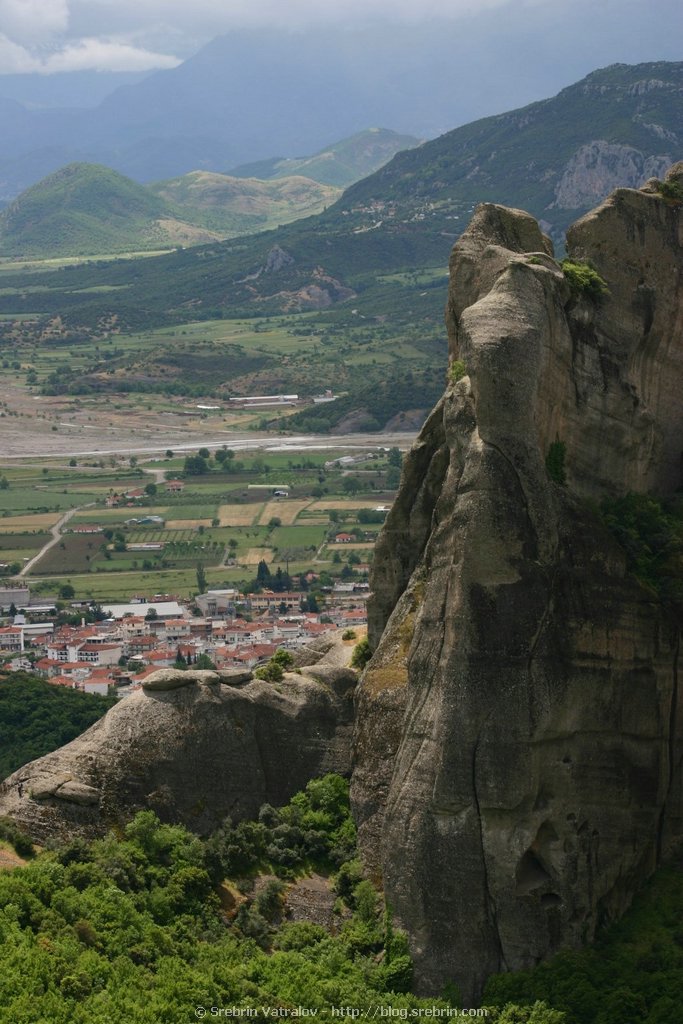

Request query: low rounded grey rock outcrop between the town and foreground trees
[{"left": 0, "top": 648, "right": 356, "bottom": 842}]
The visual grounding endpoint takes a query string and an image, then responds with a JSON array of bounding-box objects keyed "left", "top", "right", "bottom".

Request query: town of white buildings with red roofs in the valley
[{"left": 0, "top": 572, "right": 370, "bottom": 697}]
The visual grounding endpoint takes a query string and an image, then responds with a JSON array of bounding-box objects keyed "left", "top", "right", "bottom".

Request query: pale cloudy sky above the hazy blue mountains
[{"left": 0, "top": 0, "right": 683, "bottom": 81}]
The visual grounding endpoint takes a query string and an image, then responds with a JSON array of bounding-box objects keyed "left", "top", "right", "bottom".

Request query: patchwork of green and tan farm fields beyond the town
[{"left": 0, "top": 450, "right": 397, "bottom": 601}]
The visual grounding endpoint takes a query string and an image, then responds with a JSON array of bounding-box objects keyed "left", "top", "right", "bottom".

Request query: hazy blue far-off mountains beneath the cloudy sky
[{"left": 0, "top": 18, "right": 679, "bottom": 201}]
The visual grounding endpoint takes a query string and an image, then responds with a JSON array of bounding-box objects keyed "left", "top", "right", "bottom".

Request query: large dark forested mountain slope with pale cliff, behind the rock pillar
[{"left": 0, "top": 61, "right": 683, "bottom": 430}]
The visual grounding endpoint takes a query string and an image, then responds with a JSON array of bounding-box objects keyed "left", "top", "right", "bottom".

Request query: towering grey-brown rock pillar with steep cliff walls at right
[{"left": 352, "top": 166, "right": 683, "bottom": 1005}]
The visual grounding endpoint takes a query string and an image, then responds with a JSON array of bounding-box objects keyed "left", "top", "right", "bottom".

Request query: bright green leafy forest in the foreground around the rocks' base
[{"left": 0, "top": 775, "right": 683, "bottom": 1024}]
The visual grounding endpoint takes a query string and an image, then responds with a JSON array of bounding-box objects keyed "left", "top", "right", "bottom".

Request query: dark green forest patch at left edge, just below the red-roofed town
[{"left": 0, "top": 672, "right": 116, "bottom": 779}]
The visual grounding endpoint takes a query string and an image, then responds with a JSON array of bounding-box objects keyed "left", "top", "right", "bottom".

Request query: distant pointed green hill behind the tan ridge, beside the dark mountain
[{"left": 230, "top": 128, "right": 420, "bottom": 188}]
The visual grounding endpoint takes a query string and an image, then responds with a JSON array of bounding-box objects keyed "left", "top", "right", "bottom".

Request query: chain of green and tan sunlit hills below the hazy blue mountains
[{"left": 0, "top": 129, "right": 418, "bottom": 258}]
